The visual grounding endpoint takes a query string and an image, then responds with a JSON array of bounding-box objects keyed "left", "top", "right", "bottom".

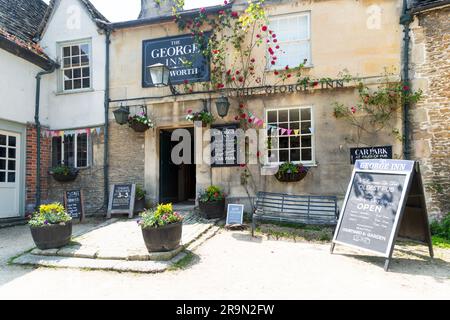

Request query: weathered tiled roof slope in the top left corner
[{"left": 0, "top": 0, "right": 47, "bottom": 42}]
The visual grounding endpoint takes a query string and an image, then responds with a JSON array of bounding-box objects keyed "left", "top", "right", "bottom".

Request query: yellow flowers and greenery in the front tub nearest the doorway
[{"left": 138, "top": 203, "right": 183, "bottom": 228}]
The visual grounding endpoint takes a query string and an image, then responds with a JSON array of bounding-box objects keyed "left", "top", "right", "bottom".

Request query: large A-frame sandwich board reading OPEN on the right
[{"left": 331, "top": 159, "right": 433, "bottom": 271}]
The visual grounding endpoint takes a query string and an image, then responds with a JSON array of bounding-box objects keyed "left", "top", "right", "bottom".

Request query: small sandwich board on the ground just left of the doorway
[{"left": 107, "top": 184, "right": 136, "bottom": 219}]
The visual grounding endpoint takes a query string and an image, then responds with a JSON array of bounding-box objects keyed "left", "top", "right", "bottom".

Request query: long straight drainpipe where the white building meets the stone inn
[{"left": 103, "top": 27, "right": 112, "bottom": 208}]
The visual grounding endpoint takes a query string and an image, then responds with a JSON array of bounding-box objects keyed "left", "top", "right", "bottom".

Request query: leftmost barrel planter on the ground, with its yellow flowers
[{"left": 28, "top": 203, "right": 72, "bottom": 250}]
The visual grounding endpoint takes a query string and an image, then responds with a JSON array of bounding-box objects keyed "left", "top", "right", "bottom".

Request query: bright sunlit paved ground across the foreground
[{"left": 0, "top": 221, "right": 450, "bottom": 299}]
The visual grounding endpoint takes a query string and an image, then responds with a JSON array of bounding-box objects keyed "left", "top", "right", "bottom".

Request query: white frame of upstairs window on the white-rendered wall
[{"left": 57, "top": 38, "right": 94, "bottom": 93}]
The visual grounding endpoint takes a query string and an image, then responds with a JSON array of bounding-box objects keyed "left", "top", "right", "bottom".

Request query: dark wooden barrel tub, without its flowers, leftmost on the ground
[{"left": 30, "top": 221, "right": 72, "bottom": 250}]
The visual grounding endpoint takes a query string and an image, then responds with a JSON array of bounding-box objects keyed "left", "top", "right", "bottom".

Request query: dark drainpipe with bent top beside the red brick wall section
[{"left": 34, "top": 63, "right": 58, "bottom": 209}]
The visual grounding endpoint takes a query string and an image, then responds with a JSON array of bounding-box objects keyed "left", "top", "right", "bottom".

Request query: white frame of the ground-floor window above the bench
[{"left": 264, "top": 105, "right": 316, "bottom": 167}]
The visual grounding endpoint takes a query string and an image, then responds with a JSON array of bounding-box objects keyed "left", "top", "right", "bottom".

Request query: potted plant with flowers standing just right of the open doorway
[{"left": 199, "top": 186, "right": 226, "bottom": 219}]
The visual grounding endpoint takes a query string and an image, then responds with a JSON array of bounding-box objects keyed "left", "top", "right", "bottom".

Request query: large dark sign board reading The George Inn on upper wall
[{"left": 142, "top": 33, "right": 210, "bottom": 88}]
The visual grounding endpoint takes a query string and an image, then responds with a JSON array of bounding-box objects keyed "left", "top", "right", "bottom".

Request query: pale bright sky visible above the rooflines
[{"left": 44, "top": 0, "right": 223, "bottom": 22}]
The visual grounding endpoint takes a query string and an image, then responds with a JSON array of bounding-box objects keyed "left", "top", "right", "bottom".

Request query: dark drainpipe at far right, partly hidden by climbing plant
[{"left": 400, "top": 0, "right": 413, "bottom": 160}]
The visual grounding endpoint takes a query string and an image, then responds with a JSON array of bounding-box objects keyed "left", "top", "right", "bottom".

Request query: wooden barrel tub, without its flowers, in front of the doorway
[{"left": 142, "top": 222, "right": 183, "bottom": 252}]
